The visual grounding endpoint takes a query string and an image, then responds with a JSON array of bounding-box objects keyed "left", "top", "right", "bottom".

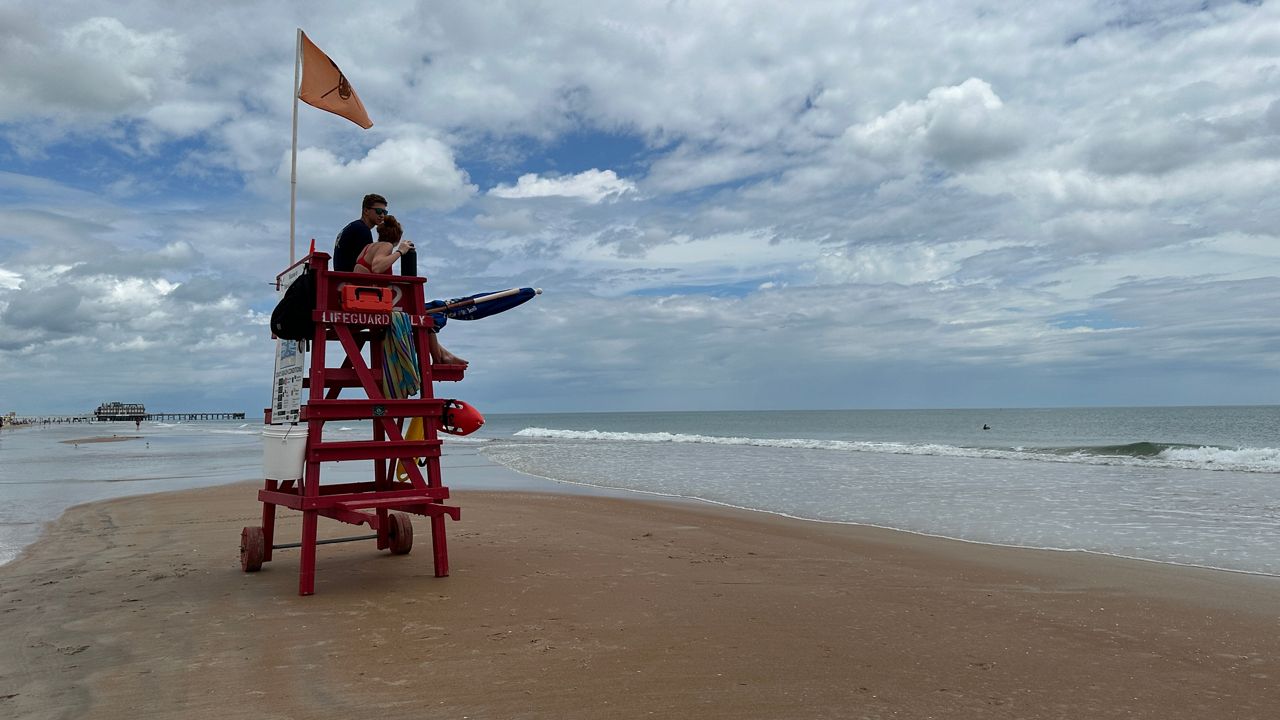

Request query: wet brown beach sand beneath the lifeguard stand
[{"left": 0, "top": 483, "right": 1280, "bottom": 720}]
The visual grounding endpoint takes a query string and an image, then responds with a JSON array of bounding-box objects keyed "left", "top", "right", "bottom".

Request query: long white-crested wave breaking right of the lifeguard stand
[{"left": 516, "top": 428, "right": 1280, "bottom": 473}]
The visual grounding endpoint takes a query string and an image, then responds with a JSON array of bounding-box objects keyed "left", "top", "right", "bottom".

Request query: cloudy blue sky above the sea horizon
[{"left": 0, "top": 0, "right": 1280, "bottom": 416}]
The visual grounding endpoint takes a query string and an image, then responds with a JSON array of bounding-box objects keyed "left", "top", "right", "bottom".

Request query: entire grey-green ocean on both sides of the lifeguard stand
[{"left": 0, "top": 406, "right": 1280, "bottom": 575}]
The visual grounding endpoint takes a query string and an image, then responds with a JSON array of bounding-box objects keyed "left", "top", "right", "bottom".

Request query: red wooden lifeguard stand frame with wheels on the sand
[{"left": 241, "top": 252, "right": 465, "bottom": 594}]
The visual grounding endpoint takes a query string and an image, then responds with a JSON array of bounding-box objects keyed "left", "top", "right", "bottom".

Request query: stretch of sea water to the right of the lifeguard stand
[{"left": 484, "top": 406, "right": 1280, "bottom": 574}]
